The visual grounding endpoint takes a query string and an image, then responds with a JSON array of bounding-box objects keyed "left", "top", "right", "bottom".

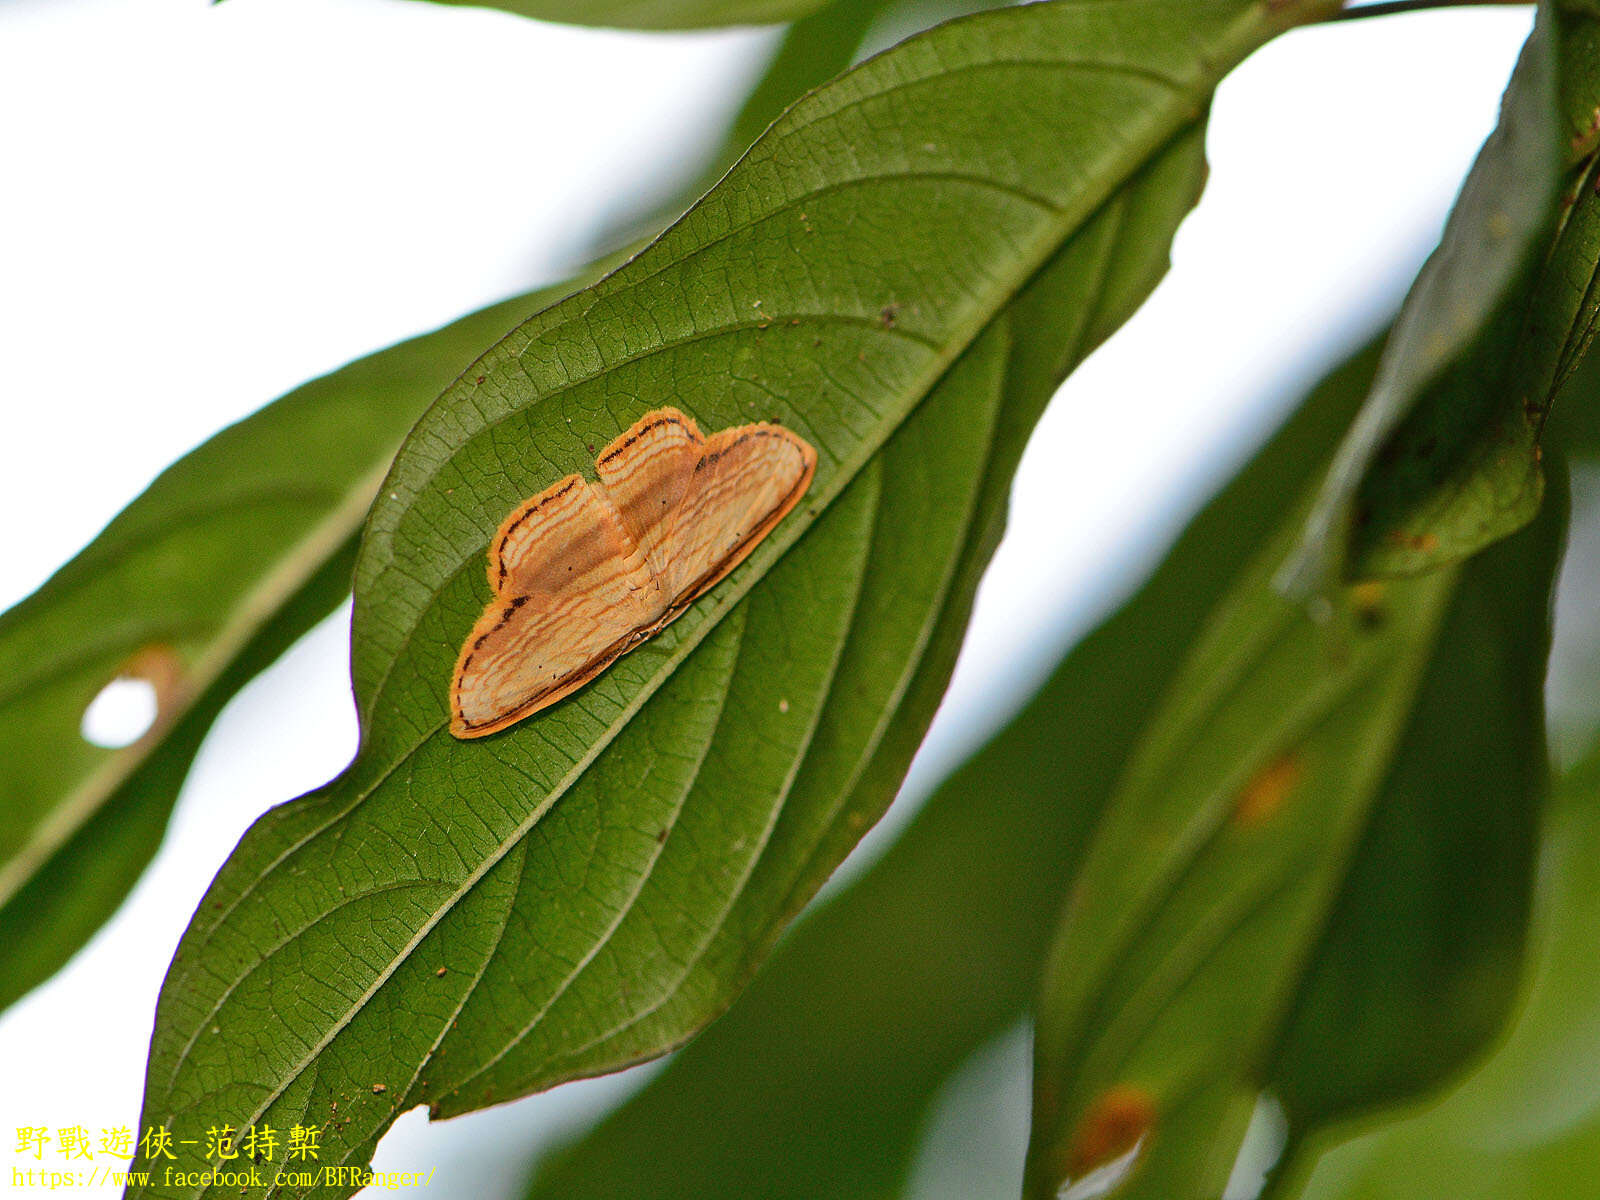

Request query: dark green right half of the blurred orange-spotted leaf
[{"left": 1266, "top": 470, "right": 1566, "bottom": 1138}]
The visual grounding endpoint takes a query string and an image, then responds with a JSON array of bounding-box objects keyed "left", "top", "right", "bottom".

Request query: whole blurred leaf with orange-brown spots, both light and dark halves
[{"left": 1029, "top": 470, "right": 1562, "bottom": 1200}]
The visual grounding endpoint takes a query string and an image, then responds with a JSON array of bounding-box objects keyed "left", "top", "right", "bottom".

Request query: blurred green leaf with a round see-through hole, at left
[{"left": 0, "top": 291, "right": 595, "bottom": 1024}]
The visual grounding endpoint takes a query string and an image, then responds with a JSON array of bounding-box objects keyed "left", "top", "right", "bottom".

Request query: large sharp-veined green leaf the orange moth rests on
[{"left": 128, "top": 0, "right": 1328, "bottom": 1192}]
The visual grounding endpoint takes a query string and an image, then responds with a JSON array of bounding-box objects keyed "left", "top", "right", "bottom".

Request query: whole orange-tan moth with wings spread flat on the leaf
[{"left": 450, "top": 408, "right": 816, "bottom": 738}]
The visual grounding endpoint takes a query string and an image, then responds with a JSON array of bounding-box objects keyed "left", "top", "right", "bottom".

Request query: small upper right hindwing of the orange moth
[{"left": 595, "top": 408, "right": 706, "bottom": 576}]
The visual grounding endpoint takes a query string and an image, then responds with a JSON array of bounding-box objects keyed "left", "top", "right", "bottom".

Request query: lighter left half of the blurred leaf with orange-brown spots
[{"left": 1027, "top": 539, "right": 1451, "bottom": 1200}]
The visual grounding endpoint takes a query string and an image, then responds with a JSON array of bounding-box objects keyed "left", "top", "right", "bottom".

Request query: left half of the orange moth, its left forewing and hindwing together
[{"left": 451, "top": 475, "right": 664, "bottom": 738}]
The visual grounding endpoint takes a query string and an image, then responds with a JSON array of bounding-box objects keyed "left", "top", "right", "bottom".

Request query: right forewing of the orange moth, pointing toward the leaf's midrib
[{"left": 661, "top": 422, "right": 816, "bottom": 611}]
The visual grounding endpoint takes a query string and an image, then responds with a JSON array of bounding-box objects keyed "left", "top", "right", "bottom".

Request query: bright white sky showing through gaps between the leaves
[{"left": 0, "top": 0, "right": 1548, "bottom": 1197}]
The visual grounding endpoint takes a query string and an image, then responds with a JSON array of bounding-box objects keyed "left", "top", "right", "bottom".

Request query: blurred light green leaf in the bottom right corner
[{"left": 1285, "top": 755, "right": 1600, "bottom": 1200}]
